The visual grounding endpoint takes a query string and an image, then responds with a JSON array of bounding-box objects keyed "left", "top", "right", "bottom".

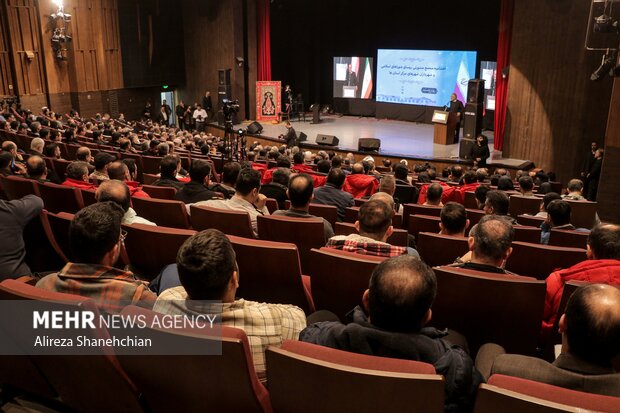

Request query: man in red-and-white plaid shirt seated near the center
[{"left": 326, "top": 199, "right": 420, "bottom": 258}]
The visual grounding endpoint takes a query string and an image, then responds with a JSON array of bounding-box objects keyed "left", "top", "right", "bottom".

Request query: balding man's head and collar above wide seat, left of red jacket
[{"left": 453, "top": 215, "right": 515, "bottom": 274}]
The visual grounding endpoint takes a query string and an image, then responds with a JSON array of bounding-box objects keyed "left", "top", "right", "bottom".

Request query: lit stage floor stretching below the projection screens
[{"left": 237, "top": 115, "right": 527, "bottom": 167}]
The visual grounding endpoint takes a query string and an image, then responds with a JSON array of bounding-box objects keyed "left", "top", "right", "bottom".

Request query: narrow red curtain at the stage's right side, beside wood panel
[{"left": 493, "top": 0, "right": 514, "bottom": 151}]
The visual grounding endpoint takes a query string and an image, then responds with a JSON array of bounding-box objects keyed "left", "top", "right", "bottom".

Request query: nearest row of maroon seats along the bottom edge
[{"left": 0, "top": 280, "right": 620, "bottom": 413}]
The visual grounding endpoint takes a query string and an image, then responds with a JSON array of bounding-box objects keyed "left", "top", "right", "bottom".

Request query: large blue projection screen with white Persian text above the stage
[{"left": 377, "top": 49, "right": 476, "bottom": 106}]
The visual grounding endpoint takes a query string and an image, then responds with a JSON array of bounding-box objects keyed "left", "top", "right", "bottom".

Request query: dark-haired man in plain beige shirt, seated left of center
[{"left": 195, "top": 168, "right": 269, "bottom": 237}]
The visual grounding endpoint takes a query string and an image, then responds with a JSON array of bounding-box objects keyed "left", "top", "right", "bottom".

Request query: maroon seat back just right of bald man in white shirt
[{"left": 131, "top": 197, "right": 191, "bottom": 229}]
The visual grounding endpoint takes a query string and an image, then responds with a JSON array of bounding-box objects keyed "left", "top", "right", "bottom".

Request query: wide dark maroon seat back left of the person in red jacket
[{"left": 430, "top": 267, "right": 546, "bottom": 354}]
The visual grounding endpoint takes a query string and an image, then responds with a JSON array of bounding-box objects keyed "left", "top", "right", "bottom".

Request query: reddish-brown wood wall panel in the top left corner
[{"left": 6, "top": 0, "right": 47, "bottom": 95}]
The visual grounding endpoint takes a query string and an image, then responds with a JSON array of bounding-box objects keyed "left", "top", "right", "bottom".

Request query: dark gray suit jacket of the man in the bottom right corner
[{"left": 491, "top": 354, "right": 620, "bottom": 397}]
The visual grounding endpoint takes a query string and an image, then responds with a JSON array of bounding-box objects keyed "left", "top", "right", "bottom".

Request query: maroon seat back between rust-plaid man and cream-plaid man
[{"left": 123, "top": 224, "right": 196, "bottom": 280}]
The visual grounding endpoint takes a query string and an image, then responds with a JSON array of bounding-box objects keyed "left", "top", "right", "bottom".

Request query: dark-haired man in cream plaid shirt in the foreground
[{"left": 153, "top": 229, "right": 306, "bottom": 381}]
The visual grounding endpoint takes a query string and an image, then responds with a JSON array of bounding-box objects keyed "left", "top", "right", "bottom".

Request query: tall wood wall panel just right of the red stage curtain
[{"left": 504, "top": 0, "right": 611, "bottom": 182}]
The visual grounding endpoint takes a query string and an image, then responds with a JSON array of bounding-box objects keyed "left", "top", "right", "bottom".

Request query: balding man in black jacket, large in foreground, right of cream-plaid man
[{"left": 299, "top": 255, "right": 483, "bottom": 412}]
